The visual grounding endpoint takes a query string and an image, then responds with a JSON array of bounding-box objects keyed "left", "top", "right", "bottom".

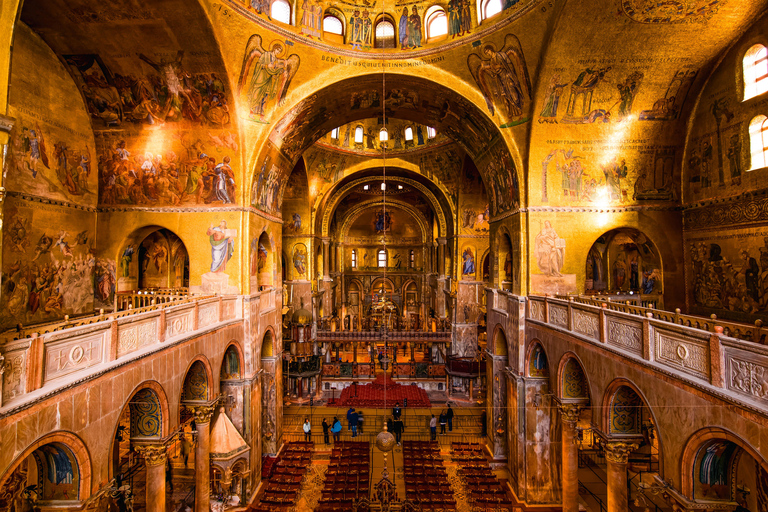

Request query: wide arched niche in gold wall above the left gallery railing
[{"left": 117, "top": 226, "right": 189, "bottom": 292}]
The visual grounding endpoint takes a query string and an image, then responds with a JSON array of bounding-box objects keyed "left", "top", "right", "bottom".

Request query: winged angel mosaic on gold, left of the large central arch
[{"left": 239, "top": 34, "right": 301, "bottom": 123}]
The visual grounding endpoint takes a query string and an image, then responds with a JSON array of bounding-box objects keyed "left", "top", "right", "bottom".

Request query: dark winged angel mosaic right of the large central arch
[{"left": 467, "top": 34, "right": 531, "bottom": 124}]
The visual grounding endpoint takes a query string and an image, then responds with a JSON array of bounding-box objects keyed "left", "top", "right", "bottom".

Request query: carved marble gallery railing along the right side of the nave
[{"left": 512, "top": 296, "right": 768, "bottom": 414}]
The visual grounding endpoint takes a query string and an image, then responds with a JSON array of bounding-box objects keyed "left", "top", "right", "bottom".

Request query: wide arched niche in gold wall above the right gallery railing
[{"left": 584, "top": 228, "right": 663, "bottom": 295}]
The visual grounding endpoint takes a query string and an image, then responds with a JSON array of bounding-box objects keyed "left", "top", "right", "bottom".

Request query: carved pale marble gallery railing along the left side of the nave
[{"left": 0, "top": 291, "right": 248, "bottom": 408}]
